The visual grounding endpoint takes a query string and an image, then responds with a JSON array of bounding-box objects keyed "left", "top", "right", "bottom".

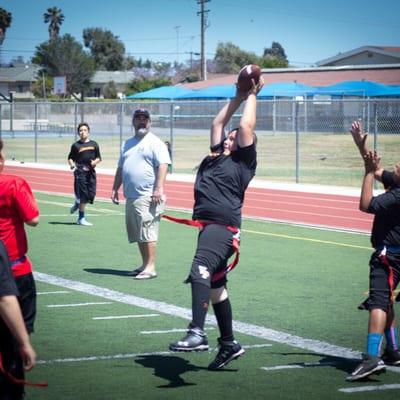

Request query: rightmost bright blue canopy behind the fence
[{"left": 317, "top": 81, "right": 400, "bottom": 97}]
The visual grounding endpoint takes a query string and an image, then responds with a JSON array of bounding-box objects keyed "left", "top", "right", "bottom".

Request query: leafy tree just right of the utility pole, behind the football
[{"left": 214, "top": 42, "right": 259, "bottom": 74}]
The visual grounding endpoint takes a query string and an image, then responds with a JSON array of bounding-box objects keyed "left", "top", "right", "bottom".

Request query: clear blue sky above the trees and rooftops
[{"left": 0, "top": 0, "right": 400, "bottom": 67}]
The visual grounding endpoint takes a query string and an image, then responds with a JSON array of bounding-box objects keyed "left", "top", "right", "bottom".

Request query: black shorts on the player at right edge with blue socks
[{"left": 364, "top": 251, "right": 400, "bottom": 312}]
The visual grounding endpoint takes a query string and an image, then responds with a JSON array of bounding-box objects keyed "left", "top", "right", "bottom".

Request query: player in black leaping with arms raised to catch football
[{"left": 169, "top": 67, "right": 263, "bottom": 370}]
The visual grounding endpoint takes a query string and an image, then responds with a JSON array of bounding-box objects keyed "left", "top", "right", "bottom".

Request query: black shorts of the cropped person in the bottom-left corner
[{"left": 0, "top": 319, "right": 24, "bottom": 400}]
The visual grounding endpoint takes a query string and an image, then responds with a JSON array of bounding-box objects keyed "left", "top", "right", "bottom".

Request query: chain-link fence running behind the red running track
[{"left": 0, "top": 98, "right": 400, "bottom": 186}]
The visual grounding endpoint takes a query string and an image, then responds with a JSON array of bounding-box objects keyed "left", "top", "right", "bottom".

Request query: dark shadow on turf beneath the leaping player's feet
[{"left": 135, "top": 355, "right": 206, "bottom": 388}]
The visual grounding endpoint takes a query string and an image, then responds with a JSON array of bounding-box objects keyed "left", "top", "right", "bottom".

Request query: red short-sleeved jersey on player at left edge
[{"left": 0, "top": 174, "right": 39, "bottom": 277}]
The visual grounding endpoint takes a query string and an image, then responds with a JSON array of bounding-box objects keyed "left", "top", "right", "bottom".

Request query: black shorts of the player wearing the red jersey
[{"left": 15, "top": 273, "right": 36, "bottom": 334}]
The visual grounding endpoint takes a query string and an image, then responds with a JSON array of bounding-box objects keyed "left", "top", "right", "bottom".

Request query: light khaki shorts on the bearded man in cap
[{"left": 125, "top": 197, "right": 165, "bottom": 243}]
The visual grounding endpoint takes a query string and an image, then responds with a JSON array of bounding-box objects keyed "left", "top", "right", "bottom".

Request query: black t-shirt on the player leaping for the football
[{"left": 193, "top": 143, "right": 257, "bottom": 227}]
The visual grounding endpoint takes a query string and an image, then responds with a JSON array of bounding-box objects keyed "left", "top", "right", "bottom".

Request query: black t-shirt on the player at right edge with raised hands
[{"left": 368, "top": 171, "right": 400, "bottom": 248}]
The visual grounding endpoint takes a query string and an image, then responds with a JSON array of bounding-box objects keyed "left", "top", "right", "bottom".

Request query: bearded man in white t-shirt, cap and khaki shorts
[{"left": 111, "top": 109, "right": 171, "bottom": 279}]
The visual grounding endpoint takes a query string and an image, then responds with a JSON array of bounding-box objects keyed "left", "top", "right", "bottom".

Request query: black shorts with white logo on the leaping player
[{"left": 186, "top": 224, "right": 233, "bottom": 289}]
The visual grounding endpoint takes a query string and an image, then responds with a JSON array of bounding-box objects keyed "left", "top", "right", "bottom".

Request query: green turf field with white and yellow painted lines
[{"left": 27, "top": 194, "right": 400, "bottom": 400}]
